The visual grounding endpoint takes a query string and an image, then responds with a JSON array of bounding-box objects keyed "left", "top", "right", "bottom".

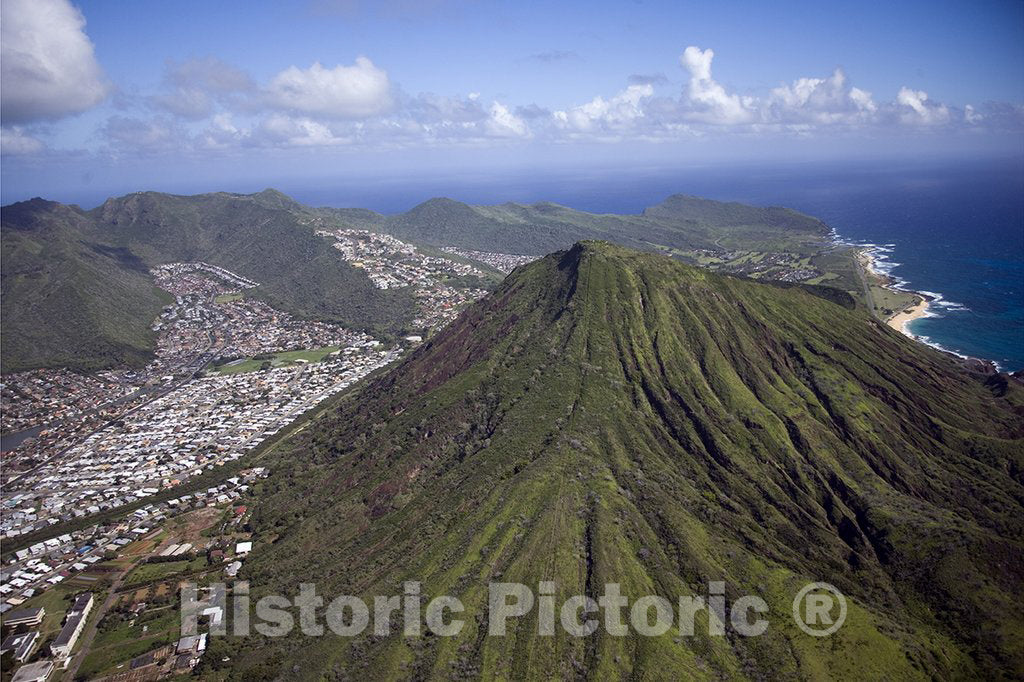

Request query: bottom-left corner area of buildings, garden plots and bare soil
[{"left": 0, "top": 467, "right": 269, "bottom": 680}]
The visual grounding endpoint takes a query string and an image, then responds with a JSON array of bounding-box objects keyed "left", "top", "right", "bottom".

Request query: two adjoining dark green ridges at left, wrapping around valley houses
[{"left": 2, "top": 190, "right": 415, "bottom": 372}]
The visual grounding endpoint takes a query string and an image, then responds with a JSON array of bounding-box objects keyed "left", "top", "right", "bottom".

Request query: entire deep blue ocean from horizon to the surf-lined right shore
[{"left": 281, "top": 159, "right": 1024, "bottom": 371}]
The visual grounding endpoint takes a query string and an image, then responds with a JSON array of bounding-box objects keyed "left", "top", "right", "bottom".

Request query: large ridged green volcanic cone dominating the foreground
[{"left": 211, "top": 243, "right": 1024, "bottom": 680}]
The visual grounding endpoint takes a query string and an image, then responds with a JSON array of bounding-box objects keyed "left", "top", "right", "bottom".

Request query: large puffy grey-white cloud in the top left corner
[{"left": 0, "top": 0, "right": 110, "bottom": 125}]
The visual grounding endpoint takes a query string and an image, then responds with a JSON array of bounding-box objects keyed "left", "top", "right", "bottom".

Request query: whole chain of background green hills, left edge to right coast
[{"left": 2, "top": 189, "right": 860, "bottom": 372}]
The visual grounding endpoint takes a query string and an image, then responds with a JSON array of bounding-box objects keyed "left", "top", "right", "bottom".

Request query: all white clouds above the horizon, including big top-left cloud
[{"left": 3, "top": 0, "right": 1024, "bottom": 155}]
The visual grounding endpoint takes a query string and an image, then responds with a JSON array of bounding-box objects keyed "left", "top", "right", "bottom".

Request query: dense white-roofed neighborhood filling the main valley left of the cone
[{"left": 0, "top": 263, "right": 400, "bottom": 538}]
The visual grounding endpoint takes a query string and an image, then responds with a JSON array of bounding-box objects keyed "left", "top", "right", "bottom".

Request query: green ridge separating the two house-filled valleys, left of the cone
[{"left": 89, "top": 190, "right": 414, "bottom": 332}]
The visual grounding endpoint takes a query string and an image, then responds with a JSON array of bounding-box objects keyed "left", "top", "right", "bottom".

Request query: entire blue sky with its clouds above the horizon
[{"left": 0, "top": 0, "right": 1024, "bottom": 203}]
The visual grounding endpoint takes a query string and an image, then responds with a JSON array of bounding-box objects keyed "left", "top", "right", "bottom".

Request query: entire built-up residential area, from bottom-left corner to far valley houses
[{"left": 0, "top": 241, "right": 512, "bottom": 682}]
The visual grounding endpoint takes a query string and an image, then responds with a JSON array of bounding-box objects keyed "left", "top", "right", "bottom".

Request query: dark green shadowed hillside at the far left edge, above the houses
[{"left": 0, "top": 200, "right": 173, "bottom": 372}]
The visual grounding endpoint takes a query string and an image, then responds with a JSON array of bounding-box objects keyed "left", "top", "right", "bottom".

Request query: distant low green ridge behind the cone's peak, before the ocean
[{"left": 316, "top": 195, "right": 864, "bottom": 296}]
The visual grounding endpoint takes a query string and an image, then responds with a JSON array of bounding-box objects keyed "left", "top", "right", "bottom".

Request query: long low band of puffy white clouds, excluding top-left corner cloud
[{"left": 37, "top": 46, "right": 1007, "bottom": 154}]
